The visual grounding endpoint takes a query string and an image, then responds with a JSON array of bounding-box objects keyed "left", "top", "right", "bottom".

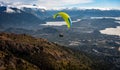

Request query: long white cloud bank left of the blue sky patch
[{"left": 0, "top": 0, "right": 93, "bottom": 8}]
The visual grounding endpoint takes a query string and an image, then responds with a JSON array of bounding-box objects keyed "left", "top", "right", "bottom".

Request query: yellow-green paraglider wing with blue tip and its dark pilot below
[{"left": 53, "top": 12, "right": 72, "bottom": 37}]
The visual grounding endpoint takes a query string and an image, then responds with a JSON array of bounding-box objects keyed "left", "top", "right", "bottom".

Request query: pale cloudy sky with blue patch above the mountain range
[{"left": 0, "top": 0, "right": 120, "bottom": 9}]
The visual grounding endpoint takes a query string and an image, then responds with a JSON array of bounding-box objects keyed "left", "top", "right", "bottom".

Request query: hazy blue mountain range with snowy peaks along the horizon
[{"left": 0, "top": 3, "right": 120, "bottom": 29}]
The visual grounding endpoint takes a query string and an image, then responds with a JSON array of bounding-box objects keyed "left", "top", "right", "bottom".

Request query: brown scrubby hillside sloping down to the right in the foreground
[{"left": 0, "top": 33, "right": 94, "bottom": 70}]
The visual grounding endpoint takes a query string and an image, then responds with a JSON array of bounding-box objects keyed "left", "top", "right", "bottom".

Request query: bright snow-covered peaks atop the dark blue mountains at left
[{"left": 0, "top": 2, "right": 46, "bottom": 13}]
